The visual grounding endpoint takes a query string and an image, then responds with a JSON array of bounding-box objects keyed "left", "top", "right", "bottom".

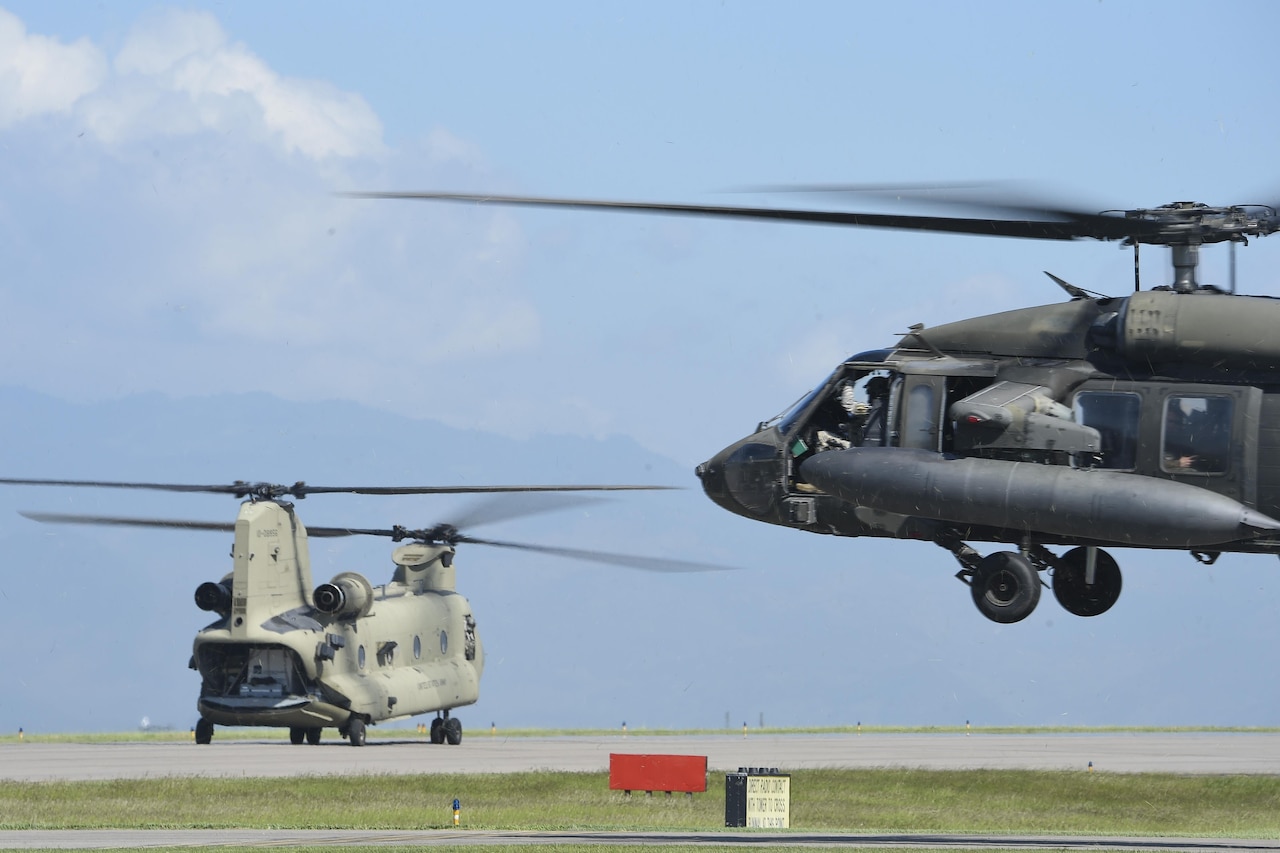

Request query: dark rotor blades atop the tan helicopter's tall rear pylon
[{"left": 0, "top": 478, "right": 680, "bottom": 501}]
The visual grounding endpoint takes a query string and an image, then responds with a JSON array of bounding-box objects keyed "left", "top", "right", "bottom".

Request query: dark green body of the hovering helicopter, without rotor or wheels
[{"left": 698, "top": 289, "right": 1280, "bottom": 616}]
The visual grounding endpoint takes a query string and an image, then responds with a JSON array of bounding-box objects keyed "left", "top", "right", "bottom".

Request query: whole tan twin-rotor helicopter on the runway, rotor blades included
[{"left": 0, "top": 479, "right": 721, "bottom": 747}]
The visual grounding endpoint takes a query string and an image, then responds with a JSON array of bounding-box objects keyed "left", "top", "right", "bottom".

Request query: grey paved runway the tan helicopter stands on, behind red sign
[{"left": 0, "top": 734, "right": 1280, "bottom": 781}]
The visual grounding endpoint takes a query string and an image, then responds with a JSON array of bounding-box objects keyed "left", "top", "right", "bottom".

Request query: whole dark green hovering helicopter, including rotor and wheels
[{"left": 347, "top": 186, "right": 1280, "bottom": 622}]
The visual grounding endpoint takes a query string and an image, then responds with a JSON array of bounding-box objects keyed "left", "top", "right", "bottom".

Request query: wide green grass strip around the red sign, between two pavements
[{"left": 0, "top": 770, "right": 1280, "bottom": 838}]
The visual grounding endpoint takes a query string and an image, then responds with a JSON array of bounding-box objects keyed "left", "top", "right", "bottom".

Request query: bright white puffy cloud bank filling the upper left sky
[{"left": 0, "top": 9, "right": 384, "bottom": 161}]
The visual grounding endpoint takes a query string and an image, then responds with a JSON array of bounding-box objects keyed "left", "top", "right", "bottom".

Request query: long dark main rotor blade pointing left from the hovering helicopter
[{"left": 338, "top": 192, "right": 1149, "bottom": 240}]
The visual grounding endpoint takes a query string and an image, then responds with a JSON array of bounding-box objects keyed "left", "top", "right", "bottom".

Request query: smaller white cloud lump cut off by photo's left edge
[{"left": 0, "top": 9, "right": 106, "bottom": 128}]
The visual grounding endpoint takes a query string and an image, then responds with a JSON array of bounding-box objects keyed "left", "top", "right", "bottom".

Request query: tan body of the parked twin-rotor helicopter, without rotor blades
[{"left": 191, "top": 501, "right": 484, "bottom": 740}]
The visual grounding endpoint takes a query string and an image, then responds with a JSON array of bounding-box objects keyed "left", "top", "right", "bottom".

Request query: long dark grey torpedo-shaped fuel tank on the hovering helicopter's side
[{"left": 800, "top": 447, "right": 1280, "bottom": 548}]
